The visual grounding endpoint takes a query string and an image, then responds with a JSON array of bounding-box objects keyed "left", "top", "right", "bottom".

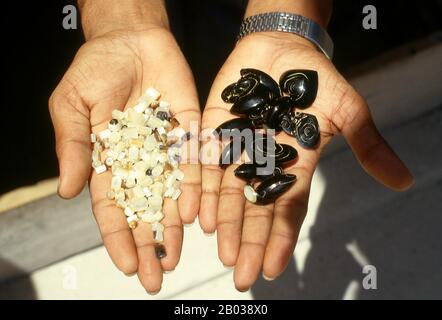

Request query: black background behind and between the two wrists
[{"left": 0, "top": 0, "right": 442, "bottom": 194}]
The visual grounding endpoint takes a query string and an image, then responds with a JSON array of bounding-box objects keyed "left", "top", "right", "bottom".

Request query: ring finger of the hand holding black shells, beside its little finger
[{"left": 216, "top": 165, "right": 245, "bottom": 266}]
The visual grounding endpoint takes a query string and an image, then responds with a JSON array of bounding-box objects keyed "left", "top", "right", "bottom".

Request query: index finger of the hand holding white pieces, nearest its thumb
[{"left": 89, "top": 171, "right": 138, "bottom": 275}]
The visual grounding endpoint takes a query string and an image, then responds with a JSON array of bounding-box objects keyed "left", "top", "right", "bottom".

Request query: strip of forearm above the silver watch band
[{"left": 246, "top": 0, "right": 333, "bottom": 28}]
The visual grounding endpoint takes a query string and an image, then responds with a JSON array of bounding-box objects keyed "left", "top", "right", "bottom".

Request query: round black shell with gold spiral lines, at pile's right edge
[{"left": 281, "top": 112, "right": 321, "bottom": 148}]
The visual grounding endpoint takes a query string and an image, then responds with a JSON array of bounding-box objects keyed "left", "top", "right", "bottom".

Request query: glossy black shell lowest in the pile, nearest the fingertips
[{"left": 255, "top": 174, "right": 296, "bottom": 204}]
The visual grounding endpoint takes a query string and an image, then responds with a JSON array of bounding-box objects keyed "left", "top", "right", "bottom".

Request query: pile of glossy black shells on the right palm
[{"left": 215, "top": 69, "right": 320, "bottom": 204}]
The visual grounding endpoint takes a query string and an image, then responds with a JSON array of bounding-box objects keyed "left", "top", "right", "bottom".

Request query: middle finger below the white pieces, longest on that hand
[{"left": 132, "top": 223, "right": 163, "bottom": 293}]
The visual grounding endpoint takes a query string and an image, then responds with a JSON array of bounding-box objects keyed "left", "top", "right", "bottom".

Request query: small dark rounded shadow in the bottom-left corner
[{"left": 0, "top": 259, "right": 37, "bottom": 300}]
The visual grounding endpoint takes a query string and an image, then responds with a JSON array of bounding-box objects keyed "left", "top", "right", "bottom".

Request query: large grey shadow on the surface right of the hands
[{"left": 252, "top": 108, "right": 442, "bottom": 299}]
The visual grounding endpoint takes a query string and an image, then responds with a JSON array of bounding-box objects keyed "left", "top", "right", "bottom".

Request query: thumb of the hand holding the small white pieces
[{"left": 49, "top": 89, "right": 91, "bottom": 198}]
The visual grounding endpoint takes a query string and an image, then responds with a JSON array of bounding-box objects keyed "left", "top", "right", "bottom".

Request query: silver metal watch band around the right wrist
[{"left": 238, "top": 12, "right": 333, "bottom": 59}]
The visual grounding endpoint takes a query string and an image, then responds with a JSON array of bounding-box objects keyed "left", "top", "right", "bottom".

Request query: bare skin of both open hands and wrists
[{"left": 49, "top": 0, "right": 413, "bottom": 293}]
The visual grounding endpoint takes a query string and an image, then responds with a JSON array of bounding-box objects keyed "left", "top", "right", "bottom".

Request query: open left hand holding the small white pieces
[{"left": 49, "top": 27, "right": 201, "bottom": 293}]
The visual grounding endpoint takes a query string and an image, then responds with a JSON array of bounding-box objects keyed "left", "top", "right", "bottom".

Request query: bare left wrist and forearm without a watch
[{"left": 78, "top": 0, "right": 169, "bottom": 40}]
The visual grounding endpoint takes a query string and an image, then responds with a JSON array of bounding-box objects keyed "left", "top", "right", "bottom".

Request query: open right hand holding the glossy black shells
[{"left": 199, "top": 32, "right": 413, "bottom": 291}]
